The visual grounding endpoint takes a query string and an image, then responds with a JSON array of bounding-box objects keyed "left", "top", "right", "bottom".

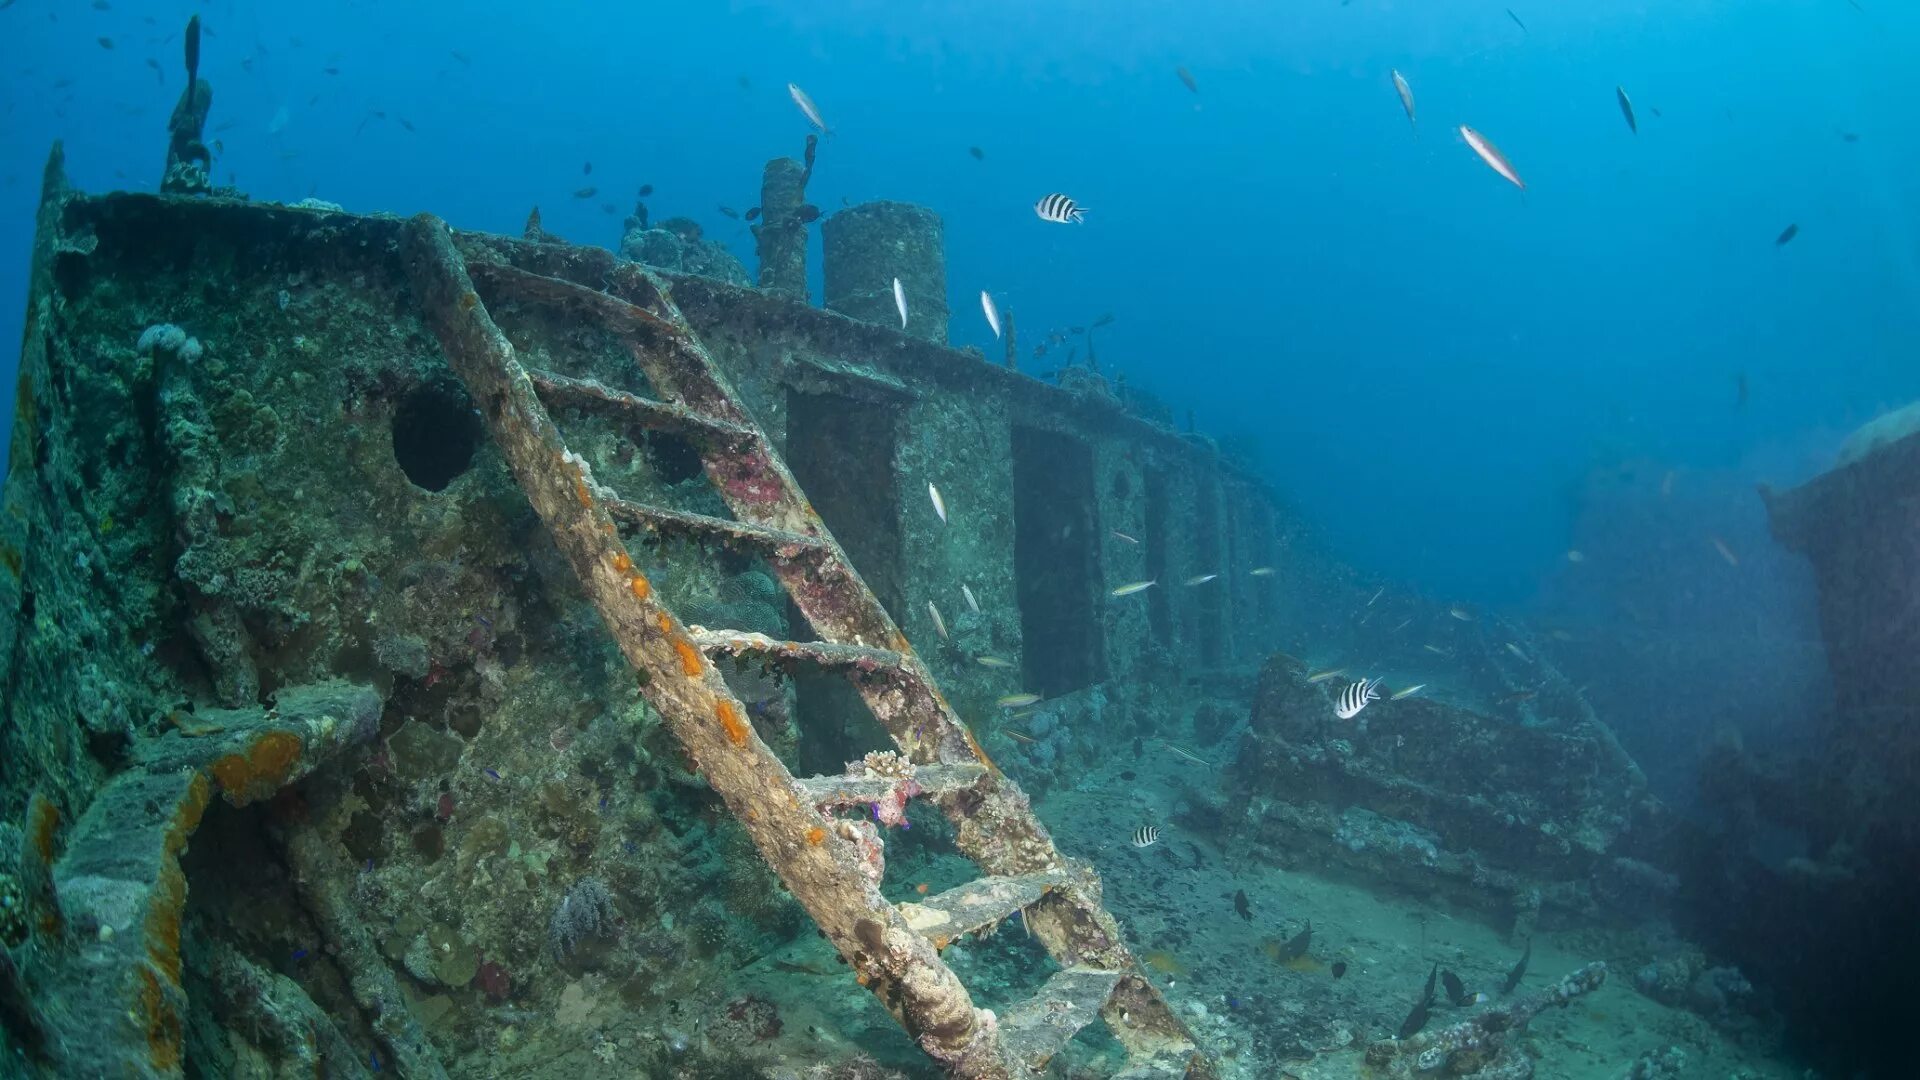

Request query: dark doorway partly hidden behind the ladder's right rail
[{"left": 787, "top": 390, "right": 906, "bottom": 774}]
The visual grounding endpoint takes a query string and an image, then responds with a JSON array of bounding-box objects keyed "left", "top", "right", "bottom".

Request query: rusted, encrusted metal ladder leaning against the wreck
[{"left": 407, "top": 215, "right": 1212, "bottom": 1080}]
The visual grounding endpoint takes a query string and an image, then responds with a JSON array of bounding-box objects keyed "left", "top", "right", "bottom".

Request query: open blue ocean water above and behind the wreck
[{"left": 0, "top": 0, "right": 1920, "bottom": 796}]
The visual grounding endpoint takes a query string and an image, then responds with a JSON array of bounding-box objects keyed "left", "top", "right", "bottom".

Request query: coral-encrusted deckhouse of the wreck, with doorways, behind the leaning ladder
[{"left": 0, "top": 136, "right": 1286, "bottom": 1078}]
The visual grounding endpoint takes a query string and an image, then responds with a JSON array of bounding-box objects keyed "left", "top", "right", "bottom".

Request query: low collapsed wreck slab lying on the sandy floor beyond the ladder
[{"left": 1227, "top": 655, "right": 1676, "bottom": 942}]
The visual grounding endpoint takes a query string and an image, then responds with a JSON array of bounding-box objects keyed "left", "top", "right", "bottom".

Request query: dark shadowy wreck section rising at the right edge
[{"left": 1712, "top": 402, "right": 1920, "bottom": 1076}]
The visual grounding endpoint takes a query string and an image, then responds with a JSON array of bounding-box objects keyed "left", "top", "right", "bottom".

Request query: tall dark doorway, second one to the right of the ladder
[{"left": 1014, "top": 427, "right": 1106, "bottom": 698}]
